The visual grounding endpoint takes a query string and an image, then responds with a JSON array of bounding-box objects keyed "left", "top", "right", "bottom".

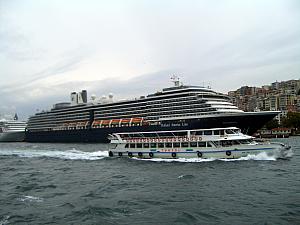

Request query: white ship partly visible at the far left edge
[{"left": 0, "top": 114, "right": 26, "bottom": 142}]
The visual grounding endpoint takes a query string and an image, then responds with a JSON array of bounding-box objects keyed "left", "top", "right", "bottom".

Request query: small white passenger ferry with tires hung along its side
[{"left": 109, "top": 127, "right": 290, "bottom": 159}]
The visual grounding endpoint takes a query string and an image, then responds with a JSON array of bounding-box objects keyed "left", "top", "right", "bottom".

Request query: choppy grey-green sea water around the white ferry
[{"left": 0, "top": 137, "right": 300, "bottom": 225}]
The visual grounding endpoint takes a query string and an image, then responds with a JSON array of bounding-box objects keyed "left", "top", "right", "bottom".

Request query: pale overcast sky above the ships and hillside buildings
[{"left": 0, "top": 0, "right": 300, "bottom": 118}]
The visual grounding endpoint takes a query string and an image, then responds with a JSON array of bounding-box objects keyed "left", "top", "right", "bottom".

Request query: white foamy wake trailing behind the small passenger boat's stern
[{"left": 0, "top": 149, "right": 108, "bottom": 160}]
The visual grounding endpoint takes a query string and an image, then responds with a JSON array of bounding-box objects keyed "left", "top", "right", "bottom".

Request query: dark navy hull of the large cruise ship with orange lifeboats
[{"left": 25, "top": 112, "right": 278, "bottom": 143}]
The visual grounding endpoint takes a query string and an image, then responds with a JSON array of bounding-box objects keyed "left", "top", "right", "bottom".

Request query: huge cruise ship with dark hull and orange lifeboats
[{"left": 25, "top": 77, "right": 279, "bottom": 143}]
